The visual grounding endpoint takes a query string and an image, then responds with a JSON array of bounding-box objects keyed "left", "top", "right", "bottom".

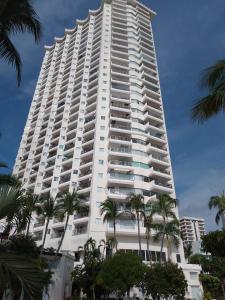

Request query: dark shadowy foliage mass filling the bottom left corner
[{"left": 0, "top": 235, "right": 51, "bottom": 300}]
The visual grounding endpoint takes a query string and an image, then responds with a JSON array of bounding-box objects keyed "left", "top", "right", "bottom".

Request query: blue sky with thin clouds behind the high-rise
[{"left": 0, "top": 0, "right": 225, "bottom": 230}]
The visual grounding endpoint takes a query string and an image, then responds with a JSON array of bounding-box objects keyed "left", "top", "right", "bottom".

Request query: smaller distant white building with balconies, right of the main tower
[{"left": 180, "top": 217, "right": 206, "bottom": 243}]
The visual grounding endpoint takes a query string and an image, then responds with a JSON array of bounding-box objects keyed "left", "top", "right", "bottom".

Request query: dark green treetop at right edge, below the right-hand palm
[{"left": 202, "top": 230, "right": 225, "bottom": 257}]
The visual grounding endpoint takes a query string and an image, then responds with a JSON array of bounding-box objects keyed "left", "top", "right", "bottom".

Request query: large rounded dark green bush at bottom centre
[{"left": 98, "top": 251, "right": 146, "bottom": 295}]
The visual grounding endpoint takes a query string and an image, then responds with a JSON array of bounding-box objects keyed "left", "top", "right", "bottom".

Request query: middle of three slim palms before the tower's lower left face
[{"left": 38, "top": 194, "right": 58, "bottom": 253}]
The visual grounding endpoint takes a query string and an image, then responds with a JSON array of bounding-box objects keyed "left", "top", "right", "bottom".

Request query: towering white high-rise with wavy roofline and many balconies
[{"left": 14, "top": 0, "right": 204, "bottom": 298}]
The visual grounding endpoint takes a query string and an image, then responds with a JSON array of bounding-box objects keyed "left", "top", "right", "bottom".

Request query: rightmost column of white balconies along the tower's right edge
[{"left": 132, "top": 6, "right": 173, "bottom": 194}]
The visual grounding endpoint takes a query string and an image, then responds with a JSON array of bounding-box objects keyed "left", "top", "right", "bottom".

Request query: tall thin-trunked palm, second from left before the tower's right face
[{"left": 127, "top": 194, "right": 145, "bottom": 255}]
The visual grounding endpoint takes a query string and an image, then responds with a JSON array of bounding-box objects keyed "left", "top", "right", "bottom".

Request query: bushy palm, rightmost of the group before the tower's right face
[{"left": 154, "top": 219, "right": 180, "bottom": 263}]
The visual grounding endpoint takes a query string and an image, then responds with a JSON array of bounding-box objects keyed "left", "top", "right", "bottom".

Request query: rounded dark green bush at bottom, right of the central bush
[{"left": 144, "top": 262, "right": 187, "bottom": 299}]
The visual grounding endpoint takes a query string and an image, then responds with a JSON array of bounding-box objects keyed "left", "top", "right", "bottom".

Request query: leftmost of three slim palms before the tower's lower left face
[{"left": 22, "top": 193, "right": 41, "bottom": 236}]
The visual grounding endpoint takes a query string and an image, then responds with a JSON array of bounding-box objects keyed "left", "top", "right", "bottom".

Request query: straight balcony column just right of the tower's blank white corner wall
[{"left": 108, "top": 1, "right": 134, "bottom": 211}]
